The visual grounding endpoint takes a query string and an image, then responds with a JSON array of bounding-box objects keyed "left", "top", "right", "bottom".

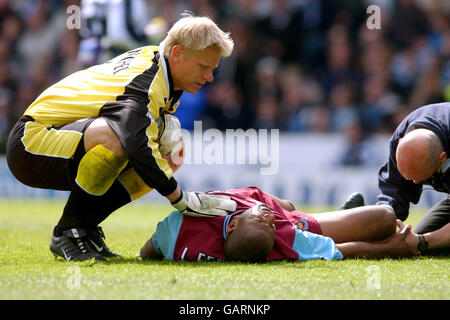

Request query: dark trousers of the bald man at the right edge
[{"left": 414, "top": 196, "right": 450, "bottom": 255}]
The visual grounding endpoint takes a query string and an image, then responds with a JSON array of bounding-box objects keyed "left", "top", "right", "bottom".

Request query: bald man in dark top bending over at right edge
[{"left": 377, "top": 103, "right": 450, "bottom": 254}]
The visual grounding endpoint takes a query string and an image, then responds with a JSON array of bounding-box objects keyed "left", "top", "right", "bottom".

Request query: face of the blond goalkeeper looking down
[{"left": 171, "top": 46, "right": 220, "bottom": 93}]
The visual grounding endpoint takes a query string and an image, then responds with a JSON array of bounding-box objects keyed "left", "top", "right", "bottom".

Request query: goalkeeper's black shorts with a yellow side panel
[{"left": 6, "top": 116, "right": 96, "bottom": 190}]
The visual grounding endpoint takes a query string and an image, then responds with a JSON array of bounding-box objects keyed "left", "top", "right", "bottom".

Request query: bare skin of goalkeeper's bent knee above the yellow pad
[{"left": 84, "top": 118, "right": 124, "bottom": 156}]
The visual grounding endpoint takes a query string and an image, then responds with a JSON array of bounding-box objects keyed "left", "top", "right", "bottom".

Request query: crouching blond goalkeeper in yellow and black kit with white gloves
[{"left": 7, "top": 13, "right": 236, "bottom": 261}]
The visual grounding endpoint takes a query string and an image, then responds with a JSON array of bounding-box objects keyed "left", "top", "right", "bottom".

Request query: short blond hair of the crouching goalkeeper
[{"left": 159, "top": 11, "right": 234, "bottom": 57}]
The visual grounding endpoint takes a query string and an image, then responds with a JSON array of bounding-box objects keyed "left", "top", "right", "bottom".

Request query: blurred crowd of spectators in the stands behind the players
[{"left": 0, "top": 0, "right": 450, "bottom": 164}]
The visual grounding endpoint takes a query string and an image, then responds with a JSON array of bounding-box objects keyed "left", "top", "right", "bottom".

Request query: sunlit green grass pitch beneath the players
[{"left": 0, "top": 199, "right": 450, "bottom": 300}]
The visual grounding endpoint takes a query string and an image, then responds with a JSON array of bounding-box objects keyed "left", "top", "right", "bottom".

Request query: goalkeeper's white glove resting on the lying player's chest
[{"left": 171, "top": 191, "right": 237, "bottom": 217}]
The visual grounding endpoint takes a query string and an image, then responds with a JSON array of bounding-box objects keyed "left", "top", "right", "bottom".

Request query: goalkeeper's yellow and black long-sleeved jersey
[{"left": 24, "top": 46, "right": 182, "bottom": 195}]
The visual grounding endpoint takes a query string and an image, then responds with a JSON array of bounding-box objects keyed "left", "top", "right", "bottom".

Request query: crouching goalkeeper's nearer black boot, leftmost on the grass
[{"left": 50, "top": 228, "right": 106, "bottom": 261}]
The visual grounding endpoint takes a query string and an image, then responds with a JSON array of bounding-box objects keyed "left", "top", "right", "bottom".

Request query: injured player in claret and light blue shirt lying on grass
[{"left": 140, "top": 187, "right": 411, "bottom": 262}]
